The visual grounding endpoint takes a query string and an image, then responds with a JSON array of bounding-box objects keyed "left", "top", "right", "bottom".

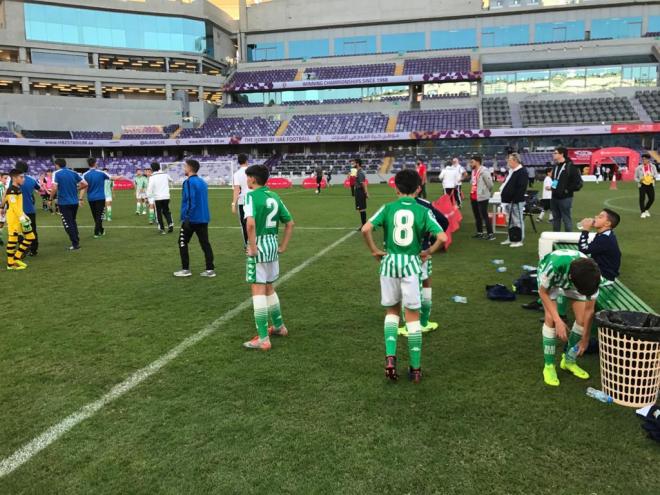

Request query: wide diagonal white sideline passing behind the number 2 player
[{"left": 0, "top": 232, "right": 356, "bottom": 478}]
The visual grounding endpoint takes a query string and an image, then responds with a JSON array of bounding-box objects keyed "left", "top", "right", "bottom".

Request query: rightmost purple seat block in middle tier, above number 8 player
[{"left": 396, "top": 108, "right": 479, "bottom": 132}]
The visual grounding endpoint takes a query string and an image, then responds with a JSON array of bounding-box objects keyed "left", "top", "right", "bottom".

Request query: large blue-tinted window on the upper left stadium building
[{"left": 24, "top": 3, "right": 213, "bottom": 53}]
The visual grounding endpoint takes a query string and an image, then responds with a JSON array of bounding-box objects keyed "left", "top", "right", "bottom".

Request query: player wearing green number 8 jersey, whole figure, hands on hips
[{"left": 362, "top": 170, "right": 447, "bottom": 383}]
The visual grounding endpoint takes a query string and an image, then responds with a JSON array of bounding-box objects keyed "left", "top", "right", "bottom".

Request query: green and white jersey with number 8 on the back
[{"left": 369, "top": 196, "right": 443, "bottom": 278}]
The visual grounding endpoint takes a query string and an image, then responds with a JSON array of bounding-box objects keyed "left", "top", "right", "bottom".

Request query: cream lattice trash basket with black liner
[{"left": 595, "top": 311, "right": 660, "bottom": 407}]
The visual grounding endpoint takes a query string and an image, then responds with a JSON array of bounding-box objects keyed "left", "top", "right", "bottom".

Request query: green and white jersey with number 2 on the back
[{"left": 243, "top": 186, "right": 293, "bottom": 263}]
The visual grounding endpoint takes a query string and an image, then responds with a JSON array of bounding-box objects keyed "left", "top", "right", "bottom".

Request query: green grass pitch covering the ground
[{"left": 0, "top": 183, "right": 660, "bottom": 494}]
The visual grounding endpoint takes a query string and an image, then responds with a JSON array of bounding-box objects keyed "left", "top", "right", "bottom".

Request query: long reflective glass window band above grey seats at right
[{"left": 483, "top": 64, "right": 658, "bottom": 95}]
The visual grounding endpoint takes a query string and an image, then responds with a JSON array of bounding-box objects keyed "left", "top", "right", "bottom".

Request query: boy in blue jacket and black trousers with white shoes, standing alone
[{"left": 174, "top": 160, "right": 215, "bottom": 277}]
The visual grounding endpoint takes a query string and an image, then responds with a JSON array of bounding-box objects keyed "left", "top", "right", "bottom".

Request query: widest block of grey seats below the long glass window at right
[{"left": 520, "top": 97, "right": 639, "bottom": 127}]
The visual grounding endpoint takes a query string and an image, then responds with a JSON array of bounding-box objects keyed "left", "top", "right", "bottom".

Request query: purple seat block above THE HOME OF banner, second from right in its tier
[{"left": 284, "top": 112, "right": 388, "bottom": 136}]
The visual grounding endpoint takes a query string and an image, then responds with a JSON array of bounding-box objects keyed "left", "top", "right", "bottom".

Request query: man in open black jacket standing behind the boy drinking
[{"left": 550, "top": 146, "right": 580, "bottom": 232}]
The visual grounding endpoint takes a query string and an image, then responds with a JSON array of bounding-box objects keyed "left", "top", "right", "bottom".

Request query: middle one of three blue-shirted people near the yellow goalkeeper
[{"left": 50, "top": 158, "right": 87, "bottom": 251}]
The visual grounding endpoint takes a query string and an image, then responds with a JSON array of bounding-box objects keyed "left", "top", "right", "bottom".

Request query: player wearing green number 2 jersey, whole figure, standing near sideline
[{"left": 243, "top": 165, "right": 293, "bottom": 351}]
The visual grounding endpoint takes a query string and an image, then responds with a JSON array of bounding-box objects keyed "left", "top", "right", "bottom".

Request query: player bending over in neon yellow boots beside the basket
[{"left": 537, "top": 249, "right": 601, "bottom": 387}]
